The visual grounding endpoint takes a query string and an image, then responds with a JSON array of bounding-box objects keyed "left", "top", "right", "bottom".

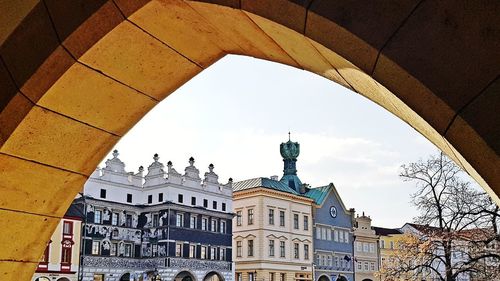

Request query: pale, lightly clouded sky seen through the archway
[{"left": 101, "top": 55, "right": 438, "bottom": 228}]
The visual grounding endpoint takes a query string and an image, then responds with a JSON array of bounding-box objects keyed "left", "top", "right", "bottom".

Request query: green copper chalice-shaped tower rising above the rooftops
[{"left": 280, "top": 133, "right": 302, "bottom": 193}]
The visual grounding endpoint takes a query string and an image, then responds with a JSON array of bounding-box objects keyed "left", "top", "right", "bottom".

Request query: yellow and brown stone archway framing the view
[{"left": 0, "top": 0, "right": 500, "bottom": 280}]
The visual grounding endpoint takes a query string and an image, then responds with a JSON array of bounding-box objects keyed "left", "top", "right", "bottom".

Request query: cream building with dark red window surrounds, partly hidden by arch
[{"left": 31, "top": 205, "right": 82, "bottom": 281}]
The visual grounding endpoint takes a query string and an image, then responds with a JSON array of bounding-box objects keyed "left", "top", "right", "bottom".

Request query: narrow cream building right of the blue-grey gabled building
[{"left": 354, "top": 213, "right": 379, "bottom": 281}]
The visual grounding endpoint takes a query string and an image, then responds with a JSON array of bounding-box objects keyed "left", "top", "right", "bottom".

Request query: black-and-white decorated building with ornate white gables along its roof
[{"left": 77, "top": 150, "right": 233, "bottom": 281}]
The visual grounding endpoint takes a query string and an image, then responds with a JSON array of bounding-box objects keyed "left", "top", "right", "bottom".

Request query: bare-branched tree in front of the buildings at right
[{"left": 381, "top": 153, "right": 500, "bottom": 281}]
